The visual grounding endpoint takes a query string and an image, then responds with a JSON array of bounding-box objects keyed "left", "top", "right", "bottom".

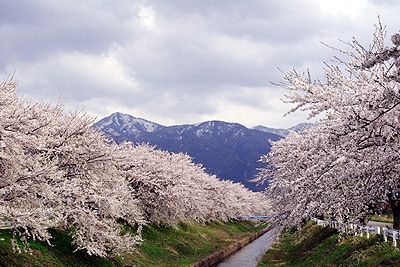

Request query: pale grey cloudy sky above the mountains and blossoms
[{"left": 0, "top": 0, "right": 400, "bottom": 128}]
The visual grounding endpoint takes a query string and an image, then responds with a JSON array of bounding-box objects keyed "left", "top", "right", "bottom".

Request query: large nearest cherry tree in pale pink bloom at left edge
[{"left": 0, "top": 76, "right": 141, "bottom": 256}]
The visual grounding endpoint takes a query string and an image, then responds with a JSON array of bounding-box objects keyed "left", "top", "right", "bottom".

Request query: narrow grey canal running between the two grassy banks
[{"left": 212, "top": 229, "right": 277, "bottom": 267}]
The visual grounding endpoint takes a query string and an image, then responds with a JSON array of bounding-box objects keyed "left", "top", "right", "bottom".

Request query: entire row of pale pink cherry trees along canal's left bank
[{"left": 0, "top": 78, "right": 269, "bottom": 256}]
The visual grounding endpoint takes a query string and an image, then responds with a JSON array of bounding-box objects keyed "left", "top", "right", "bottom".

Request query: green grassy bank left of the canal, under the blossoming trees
[{"left": 0, "top": 221, "right": 266, "bottom": 267}]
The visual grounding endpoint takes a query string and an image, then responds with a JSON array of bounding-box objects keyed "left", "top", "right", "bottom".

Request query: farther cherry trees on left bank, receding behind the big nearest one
[{"left": 118, "top": 142, "right": 269, "bottom": 225}]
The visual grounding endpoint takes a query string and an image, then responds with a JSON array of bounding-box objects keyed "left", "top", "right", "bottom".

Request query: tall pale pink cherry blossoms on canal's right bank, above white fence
[{"left": 258, "top": 23, "right": 400, "bottom": 229}]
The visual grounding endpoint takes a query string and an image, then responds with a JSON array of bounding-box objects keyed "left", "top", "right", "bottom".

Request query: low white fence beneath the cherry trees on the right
[{"left": 312, "top": 218, "right": 400, "bottom": 247}]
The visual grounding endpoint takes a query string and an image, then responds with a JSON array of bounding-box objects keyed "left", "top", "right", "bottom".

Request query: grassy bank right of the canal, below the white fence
[{"left": 258, "top": 221, "right": 400, "bottom": 267}]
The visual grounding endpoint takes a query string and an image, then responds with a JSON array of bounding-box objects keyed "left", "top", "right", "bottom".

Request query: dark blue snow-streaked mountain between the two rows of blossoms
[{"left": 95, "top": 113, "right": 306, "bottom": 191}]
